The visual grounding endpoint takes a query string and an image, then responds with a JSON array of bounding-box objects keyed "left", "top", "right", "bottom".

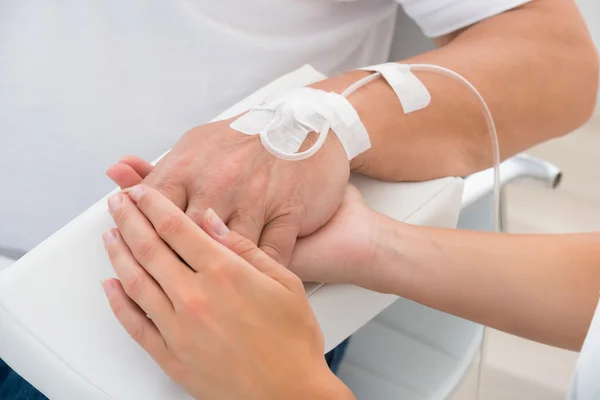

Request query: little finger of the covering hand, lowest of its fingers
[{"left": 102, "top": 279, "right": 171, "bottom": 365}]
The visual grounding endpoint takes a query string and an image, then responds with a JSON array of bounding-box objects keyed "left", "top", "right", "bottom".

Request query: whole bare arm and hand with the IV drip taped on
[{"left": 109, "top": 0, "right": 598, "bottom": 288}]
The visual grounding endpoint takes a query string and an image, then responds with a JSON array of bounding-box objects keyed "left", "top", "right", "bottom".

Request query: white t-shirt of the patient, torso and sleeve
[{"left": 0, "top": 0, "right": 528, "bottom": 253}]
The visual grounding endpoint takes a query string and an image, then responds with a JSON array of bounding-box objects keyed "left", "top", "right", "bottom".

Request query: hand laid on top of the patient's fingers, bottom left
[{"left": 103, "top": 185, "right": 353, "bottom": 400}]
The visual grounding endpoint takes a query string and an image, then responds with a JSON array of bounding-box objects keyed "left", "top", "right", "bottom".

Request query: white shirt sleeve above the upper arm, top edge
[{"left": 396, "top": 0, "right": 531, "bottom": 38}]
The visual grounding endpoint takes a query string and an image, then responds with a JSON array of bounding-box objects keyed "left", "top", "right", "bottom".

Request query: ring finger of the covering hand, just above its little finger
[{"left": 102, "top": 229, "right": 175, "bottom": 334}]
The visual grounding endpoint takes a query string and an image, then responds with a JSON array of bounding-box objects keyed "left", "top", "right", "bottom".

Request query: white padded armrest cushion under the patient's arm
[{"left": 0, "top": 66, "right": 462, "bottom": 400}]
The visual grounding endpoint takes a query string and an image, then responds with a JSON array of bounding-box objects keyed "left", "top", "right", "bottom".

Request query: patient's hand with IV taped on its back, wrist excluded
[{"left": 107, "top": 117, "right": 350, "bottom": 265}]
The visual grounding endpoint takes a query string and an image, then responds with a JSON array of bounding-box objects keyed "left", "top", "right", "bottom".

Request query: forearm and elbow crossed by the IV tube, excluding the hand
[{"left": 316, "top": 0, "right": 598, "bottom": 181}]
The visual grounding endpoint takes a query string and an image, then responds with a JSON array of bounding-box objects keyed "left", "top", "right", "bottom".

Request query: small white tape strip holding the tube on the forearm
[{"left": 359, "top": 62, "right": 431, "bottom": 114}]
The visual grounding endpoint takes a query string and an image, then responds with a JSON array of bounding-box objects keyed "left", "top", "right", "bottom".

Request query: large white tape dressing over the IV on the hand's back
[{"left": 230, "top": 87, "right": 371, "bottom": 159}]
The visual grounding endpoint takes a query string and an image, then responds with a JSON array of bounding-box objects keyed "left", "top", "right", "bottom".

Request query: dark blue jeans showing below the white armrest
[{"left": 0, "top": 339, "right": 349, "bottom": 400}]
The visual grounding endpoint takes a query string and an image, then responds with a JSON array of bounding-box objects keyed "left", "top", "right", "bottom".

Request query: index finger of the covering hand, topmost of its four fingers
[{"left": 129, "top": 185, "right": 219, "bottom": 271}]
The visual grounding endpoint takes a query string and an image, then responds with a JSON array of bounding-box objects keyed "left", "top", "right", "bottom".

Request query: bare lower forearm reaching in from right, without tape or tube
[{"left": 377, "top": 219, "right": 600, "bottom": 350}]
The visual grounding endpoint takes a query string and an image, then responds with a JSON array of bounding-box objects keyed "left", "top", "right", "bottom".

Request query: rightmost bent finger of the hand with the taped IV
[{"left": 258, "top": 215, "right": 299, "bottom": 266}]
